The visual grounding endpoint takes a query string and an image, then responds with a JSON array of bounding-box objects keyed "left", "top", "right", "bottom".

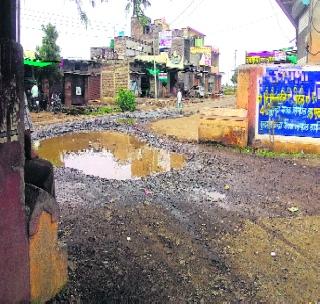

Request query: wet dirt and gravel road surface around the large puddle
[{"left": 36, "top": 105, "right": 320, "bottom": 303}]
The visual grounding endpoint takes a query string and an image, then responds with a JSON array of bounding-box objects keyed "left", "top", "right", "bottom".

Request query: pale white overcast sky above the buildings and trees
[{"left": 21, "top": 0, "right": 295, "bottom": 83}]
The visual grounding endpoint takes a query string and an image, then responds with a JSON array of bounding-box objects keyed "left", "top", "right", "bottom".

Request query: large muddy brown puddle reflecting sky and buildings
[{"left": 35, "top": 132, "right": 185, "bottom": 180}]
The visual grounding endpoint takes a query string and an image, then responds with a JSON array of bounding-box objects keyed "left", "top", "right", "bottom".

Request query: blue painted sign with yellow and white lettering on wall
[{"left": 258, "top": 67, "right": 320, "bottom": 138}]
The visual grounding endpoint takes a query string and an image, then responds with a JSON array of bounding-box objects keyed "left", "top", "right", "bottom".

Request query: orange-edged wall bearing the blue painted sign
[{"left": 237, "top": 65, "right": 320, "bottom": 153}]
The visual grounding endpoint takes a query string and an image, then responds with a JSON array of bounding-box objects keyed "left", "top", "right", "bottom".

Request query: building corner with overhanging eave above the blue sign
[{"left": 276, "top": 0, "right": 320, "bottom": 64}]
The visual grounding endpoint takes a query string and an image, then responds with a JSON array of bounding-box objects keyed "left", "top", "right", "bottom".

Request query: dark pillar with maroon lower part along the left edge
[{"left": 0, "top": 40, "right": 30, "bottom": 303}]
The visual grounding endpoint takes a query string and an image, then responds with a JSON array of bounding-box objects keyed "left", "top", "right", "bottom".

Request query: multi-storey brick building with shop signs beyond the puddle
[{"left": 98, "top": 17, "right": 221, "bottom": 100}]
